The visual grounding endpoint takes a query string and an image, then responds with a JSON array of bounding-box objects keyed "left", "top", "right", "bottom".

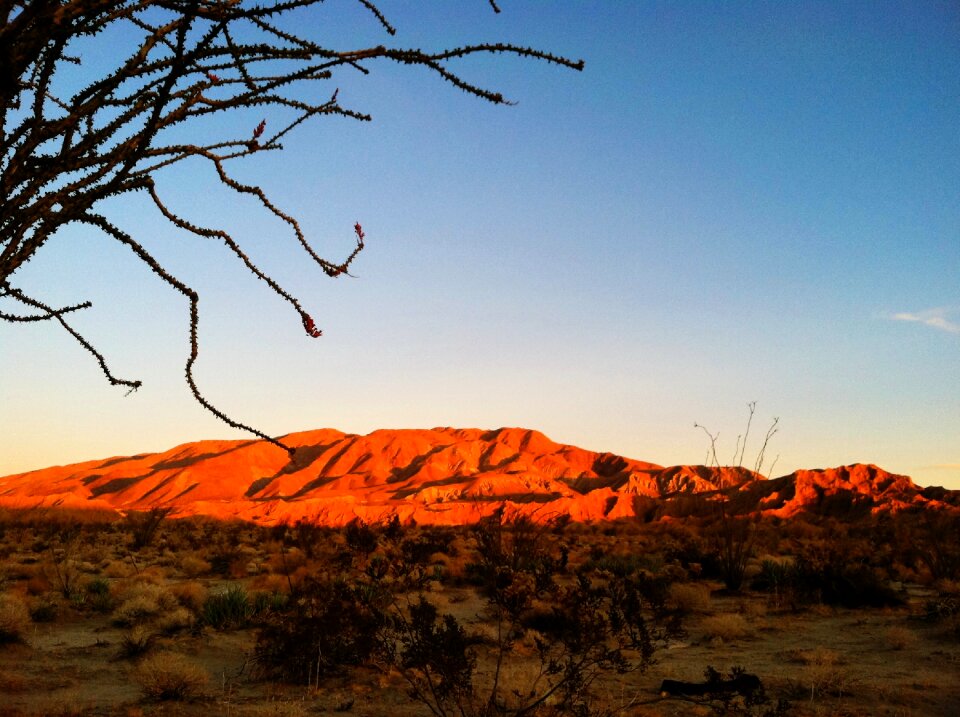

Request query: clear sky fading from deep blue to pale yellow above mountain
[{"left": 0, "top": 0, "right": 960, "bottom": 489}]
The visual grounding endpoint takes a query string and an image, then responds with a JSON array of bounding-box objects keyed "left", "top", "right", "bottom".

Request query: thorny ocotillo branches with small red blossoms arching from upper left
[{"left": 0, "top": 0, "right": 583, "bottom": 451}]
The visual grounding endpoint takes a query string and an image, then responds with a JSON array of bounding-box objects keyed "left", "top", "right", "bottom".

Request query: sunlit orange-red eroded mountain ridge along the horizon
[{"left": 0, "top": 428, "right": 960, "bottom": 525}]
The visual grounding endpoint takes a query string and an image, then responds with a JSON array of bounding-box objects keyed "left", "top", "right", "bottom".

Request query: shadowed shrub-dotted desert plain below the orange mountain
[{"left": 0, "top": 510, "right": 960, "bottom": 717}]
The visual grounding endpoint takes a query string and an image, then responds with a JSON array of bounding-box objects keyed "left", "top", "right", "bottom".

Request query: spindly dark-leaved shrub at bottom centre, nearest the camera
[{"left": 408, "top": 563, "right": 678, "bottom": 715}]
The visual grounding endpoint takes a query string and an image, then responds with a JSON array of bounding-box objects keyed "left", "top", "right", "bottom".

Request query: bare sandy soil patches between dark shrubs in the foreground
[{"left": 0, "top": 590, "right": 960, "bottom": 717}]
